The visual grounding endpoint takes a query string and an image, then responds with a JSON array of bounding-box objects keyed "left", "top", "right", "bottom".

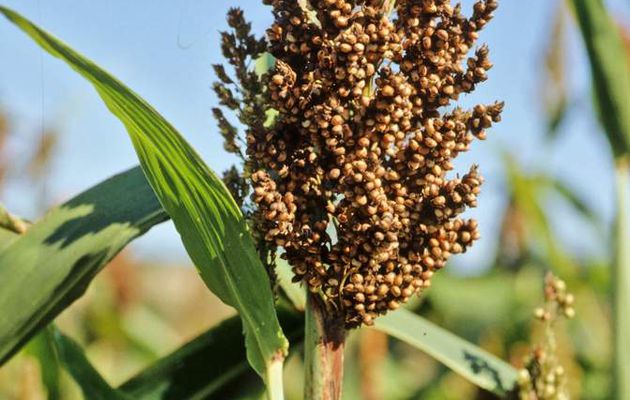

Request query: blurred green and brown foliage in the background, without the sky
[{"left": 0, "top": 0, "right": 630, "bottom": 400}]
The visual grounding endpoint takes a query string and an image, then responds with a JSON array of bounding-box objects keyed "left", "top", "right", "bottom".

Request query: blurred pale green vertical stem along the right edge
[{"left": 612, "top": 158, "right": 630, "bottom": 399}]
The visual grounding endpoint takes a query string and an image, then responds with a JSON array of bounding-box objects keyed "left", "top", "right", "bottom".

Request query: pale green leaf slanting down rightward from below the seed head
[{"left": 374, "top": 310, "right": 517, "bottom": 396}]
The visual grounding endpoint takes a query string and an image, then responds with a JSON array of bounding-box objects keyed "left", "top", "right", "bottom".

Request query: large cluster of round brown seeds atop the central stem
[{"left": 247, "top": 0, "right": 503, "bottom": 328}]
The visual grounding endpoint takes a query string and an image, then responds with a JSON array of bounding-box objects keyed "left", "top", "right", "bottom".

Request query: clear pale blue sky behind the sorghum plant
[{"left": 0, "top": 0, "right": 630, "bottom": 271}]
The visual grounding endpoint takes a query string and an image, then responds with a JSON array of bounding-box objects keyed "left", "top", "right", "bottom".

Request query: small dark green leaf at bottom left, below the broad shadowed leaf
[{"left": 53, "top": 330, "right": 133, "bottom": 400}]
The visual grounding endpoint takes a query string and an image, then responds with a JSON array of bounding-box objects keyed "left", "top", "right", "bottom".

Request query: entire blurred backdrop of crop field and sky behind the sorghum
[{"left": 0, "top": 0, "right": 630, "bottom": 400}]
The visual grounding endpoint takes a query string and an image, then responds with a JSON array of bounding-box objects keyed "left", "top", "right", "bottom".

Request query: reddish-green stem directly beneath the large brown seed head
[{"left": 304, "top": 294, "right": 346, "bottom": 400}]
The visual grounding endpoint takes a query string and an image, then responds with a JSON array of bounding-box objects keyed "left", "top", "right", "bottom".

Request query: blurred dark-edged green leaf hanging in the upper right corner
[{"left": 572, "top": 0, "right": 630, "bottom": 157}]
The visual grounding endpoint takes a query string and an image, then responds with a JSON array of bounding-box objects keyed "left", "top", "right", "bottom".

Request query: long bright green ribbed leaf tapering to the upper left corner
[{"left": 0, "top": 7, "right": 288, "bottom": 382}]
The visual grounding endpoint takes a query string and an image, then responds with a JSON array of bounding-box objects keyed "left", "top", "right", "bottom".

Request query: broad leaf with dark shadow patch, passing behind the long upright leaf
[{"left": 0, "top": 168, "right": 167, "bottom": 363}]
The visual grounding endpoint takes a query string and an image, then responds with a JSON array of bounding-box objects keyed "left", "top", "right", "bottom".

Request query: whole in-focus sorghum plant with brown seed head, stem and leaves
[{"left": 0, "top": 0, "right": 552, "bottom": 400}]
